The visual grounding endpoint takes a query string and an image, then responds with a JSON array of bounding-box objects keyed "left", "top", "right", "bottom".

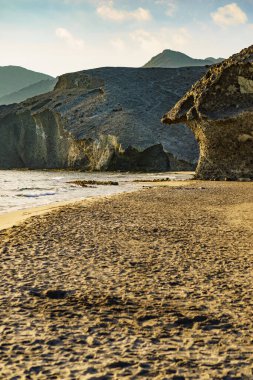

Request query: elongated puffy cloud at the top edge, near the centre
[{"left": 97, "top": 0, "right": 152, "bottom": 22}]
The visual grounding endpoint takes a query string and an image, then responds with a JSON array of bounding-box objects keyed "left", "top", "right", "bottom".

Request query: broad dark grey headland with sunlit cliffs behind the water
[{"left": 0, "top": 68, "right": 206, "bottom": 171}]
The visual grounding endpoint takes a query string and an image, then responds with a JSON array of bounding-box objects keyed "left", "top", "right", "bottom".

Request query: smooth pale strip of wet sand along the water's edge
[{"left": 0, "top": 180, "right": 192, "bottom": 231}]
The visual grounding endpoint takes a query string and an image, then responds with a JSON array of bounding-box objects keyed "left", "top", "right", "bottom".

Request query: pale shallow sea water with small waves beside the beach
[{"left": 0, "top": 170, "right": 191, "bottom": 214}]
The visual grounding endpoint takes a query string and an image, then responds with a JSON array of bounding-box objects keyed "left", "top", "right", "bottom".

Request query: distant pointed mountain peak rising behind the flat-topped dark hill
[{"left": 143, "top": 49, "right": 224, "bottom": 68}]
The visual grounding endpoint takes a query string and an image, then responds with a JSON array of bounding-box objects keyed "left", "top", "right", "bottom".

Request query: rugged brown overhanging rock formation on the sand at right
[{"left": 162, "top": 45, "right": 253, "bottom": 180}]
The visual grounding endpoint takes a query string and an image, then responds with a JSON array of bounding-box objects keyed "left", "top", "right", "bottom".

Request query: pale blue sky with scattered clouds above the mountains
[{"left": 0, "top": 0, "right": 253, "bottom": 76}]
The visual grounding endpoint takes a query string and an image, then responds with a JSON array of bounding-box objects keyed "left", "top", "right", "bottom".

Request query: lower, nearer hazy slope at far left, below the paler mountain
[{"left": 0, "top": 78, "right": 57, "bottom": 105}]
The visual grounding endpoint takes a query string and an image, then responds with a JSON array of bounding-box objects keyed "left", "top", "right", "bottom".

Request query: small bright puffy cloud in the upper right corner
[{"left": 211, "top": 3, "right": 248, "bottom": 26}]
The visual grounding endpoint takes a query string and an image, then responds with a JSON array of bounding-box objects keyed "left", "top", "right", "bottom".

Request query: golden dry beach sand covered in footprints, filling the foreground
[{"left": 0, "top": 181, "right": 253, "bottom": 380}]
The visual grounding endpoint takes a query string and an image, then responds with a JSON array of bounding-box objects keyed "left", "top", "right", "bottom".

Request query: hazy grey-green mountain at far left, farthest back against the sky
[{"left": 0, "top": 66, "right": 53, "bottom": 97}]
